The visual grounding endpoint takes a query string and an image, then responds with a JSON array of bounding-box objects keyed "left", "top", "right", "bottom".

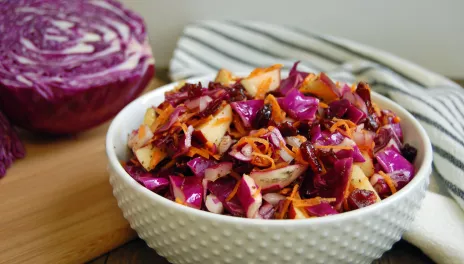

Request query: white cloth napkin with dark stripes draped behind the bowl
[{"left": 170, "top": 21, "right": 464, "bottom": 263}]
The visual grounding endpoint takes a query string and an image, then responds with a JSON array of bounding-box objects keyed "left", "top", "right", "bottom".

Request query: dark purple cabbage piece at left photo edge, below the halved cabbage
[{"left": 0, "top": 112, "right": 26, "bottom": 178}]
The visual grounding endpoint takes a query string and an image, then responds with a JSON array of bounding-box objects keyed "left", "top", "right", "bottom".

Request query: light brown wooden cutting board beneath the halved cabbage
[{"left": 0, "top": 80, "right": 164, "bottom": 264}]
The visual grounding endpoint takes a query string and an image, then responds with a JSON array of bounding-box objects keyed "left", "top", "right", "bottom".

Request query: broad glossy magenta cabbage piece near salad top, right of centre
[{"left": 277, "top": 89, "right": 319, "bottom": 121}]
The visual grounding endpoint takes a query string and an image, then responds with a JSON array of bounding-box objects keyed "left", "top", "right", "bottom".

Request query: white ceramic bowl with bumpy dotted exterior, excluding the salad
[{"left": 106, "top": 76, "right": 432, "bottom": 264}]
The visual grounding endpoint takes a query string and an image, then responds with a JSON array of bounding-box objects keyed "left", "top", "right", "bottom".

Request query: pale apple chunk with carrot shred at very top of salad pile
[{"left": 240, "top": 67, "right": 280, "bottom": 97}]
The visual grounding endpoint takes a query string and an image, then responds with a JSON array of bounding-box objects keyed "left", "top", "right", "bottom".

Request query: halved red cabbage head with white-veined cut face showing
[{"left": 0, "top": 0, "right": 154, "bottom": 133}]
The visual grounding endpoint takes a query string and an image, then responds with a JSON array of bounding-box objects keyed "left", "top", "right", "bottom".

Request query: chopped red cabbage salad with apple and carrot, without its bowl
[{"left": 122, "top": 63, "right": 417, "bottom": 219}]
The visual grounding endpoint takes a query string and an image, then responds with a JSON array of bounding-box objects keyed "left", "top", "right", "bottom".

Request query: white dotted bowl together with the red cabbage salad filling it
[{"left": 106, "top": 63, "right": 432, "bottom": 263}]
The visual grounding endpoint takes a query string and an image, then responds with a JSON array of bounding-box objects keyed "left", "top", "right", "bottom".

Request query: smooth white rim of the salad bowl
[{"left": 105, "top": 74, "right": 433, "bottom": 226}]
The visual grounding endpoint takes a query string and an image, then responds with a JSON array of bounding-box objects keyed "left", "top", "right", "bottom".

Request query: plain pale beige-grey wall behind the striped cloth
[{"left": 121, "top": 0, "right": 464, "bottom": 78}]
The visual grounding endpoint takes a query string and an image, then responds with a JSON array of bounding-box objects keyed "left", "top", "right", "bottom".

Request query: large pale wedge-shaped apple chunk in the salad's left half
[{"left": 198, "top": 105, "right": 232, "bottom": 146}]
